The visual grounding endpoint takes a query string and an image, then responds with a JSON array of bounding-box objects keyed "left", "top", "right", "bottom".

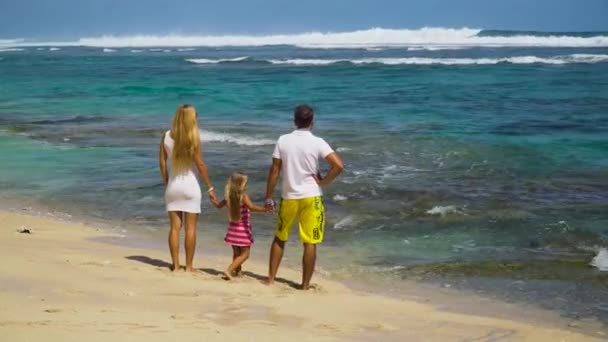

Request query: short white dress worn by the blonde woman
[{"left": 163, "top": 131, "right": 201, "bottom": 214}]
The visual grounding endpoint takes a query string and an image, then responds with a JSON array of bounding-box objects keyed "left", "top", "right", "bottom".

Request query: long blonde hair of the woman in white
[{"left": 171, "top": 104, "right": 200, "bottom": 173}]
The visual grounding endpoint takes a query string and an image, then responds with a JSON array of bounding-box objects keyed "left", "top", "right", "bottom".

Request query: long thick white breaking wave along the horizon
[{"left": 0, "top": 27, "right": 608, "bottom": 48}]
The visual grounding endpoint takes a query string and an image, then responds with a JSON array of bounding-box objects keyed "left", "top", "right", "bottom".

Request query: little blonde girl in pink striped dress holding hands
[{"left": 211, "top": 172, "right": 269, "bottom": 280}]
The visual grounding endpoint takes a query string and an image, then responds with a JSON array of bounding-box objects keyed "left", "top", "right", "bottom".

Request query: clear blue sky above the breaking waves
[{"left": 0, "top": 0, "right": 608, "bottom": 39}]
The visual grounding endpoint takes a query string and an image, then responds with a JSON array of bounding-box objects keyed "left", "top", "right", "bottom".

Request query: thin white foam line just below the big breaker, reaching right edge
[{"left": 267, "top": 54, "right": 608, "bottom": 66}]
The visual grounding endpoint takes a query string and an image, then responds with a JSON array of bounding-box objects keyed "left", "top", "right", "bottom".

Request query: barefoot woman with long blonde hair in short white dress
[{"left": 159, "top": 104, "right": 216, "bottom": 271}]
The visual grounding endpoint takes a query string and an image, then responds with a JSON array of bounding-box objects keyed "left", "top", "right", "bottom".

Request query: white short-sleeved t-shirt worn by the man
[{"left": 272, "top": 129, "right": 334, "bottom": 199}]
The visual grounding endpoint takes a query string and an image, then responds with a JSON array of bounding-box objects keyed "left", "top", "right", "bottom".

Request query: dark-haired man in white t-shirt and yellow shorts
[{"left": 265, "top": 105, "right": 344, "bottom": 290}]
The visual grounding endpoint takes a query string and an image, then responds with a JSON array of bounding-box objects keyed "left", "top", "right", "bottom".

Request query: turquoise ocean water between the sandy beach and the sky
[{"left": 0, "top": 30, "right": 608, "bottom": 319}]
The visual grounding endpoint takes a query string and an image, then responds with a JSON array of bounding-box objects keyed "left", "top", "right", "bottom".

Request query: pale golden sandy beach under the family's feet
[{"left": 0, "top": 211, "right": 601, "bottom": 341}]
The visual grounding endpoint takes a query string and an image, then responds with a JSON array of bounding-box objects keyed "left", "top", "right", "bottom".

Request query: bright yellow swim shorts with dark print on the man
[{"left": 275, "top": 196, "right": 325, "bottom": 244}]
